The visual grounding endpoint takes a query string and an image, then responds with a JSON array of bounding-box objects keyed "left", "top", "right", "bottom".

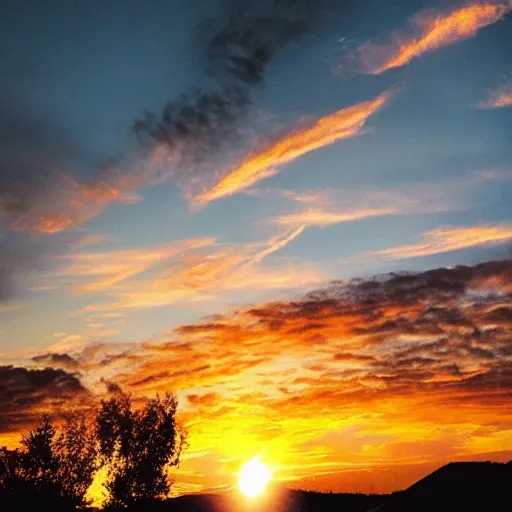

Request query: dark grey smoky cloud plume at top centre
[{"left": 135, "top": 0, "right": 350, "bottom": 179}]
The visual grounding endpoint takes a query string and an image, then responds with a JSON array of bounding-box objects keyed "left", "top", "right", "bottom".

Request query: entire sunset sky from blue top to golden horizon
[{"left": 0, "top": 0, "right": 512, "bottom": 500}]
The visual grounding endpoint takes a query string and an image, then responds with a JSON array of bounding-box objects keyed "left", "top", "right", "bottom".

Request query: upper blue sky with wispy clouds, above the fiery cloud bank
[{"left": 0, "top": 0, "right": 512, "bottom": 496}]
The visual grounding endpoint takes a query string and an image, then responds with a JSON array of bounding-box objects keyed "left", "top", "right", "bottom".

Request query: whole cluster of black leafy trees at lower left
[{"left": 0, "top": 393, "right": 186, "bottom": 511}]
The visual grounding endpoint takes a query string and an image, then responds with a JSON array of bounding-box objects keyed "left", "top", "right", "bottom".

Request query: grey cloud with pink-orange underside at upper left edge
[{"left": 0, "top": 98, "right": 146, "bottom": 234}]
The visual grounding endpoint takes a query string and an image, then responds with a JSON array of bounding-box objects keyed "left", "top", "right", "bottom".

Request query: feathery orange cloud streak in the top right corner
[{"left": 359, "top": 2, "right": 512, "bottom": 75}]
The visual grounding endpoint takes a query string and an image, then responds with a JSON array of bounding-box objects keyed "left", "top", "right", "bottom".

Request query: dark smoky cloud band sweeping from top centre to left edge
[{"left": 0, "top": 0, "right": 348, "bottom": 234}]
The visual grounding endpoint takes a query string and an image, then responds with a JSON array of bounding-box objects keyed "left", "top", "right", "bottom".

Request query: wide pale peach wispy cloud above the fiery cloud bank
[{"left": 61, "top": 226, "right": 316, "bottom": 313}]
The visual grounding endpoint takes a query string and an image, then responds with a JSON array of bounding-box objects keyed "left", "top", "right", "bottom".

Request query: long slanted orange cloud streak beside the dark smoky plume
[{"left": 194, "top": 91, "right": 392, "bottom": 204}]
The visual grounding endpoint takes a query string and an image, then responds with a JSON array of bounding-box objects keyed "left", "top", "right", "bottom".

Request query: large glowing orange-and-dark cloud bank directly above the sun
[{"left": 2, "top": 260, "right": 512, "bottom": 492}]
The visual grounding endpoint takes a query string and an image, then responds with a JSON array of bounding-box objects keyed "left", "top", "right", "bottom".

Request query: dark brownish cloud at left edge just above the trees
[{"left": 0, "top": 366, "right": 88, "bottom": 433}]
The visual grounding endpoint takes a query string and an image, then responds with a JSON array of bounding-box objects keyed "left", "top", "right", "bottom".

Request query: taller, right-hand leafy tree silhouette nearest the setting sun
[{"left": 96, "top": 393, "right": 185, "bottom": 508}]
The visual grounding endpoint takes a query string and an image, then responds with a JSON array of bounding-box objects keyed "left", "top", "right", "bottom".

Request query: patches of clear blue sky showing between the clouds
[{"left": 0, "top": 1, "right": 512, "bottom": 349}]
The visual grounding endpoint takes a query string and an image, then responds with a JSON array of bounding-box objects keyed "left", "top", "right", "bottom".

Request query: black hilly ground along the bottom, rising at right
[{"left": 152, "top": 461, "right": 512, "bottom": 512}]
